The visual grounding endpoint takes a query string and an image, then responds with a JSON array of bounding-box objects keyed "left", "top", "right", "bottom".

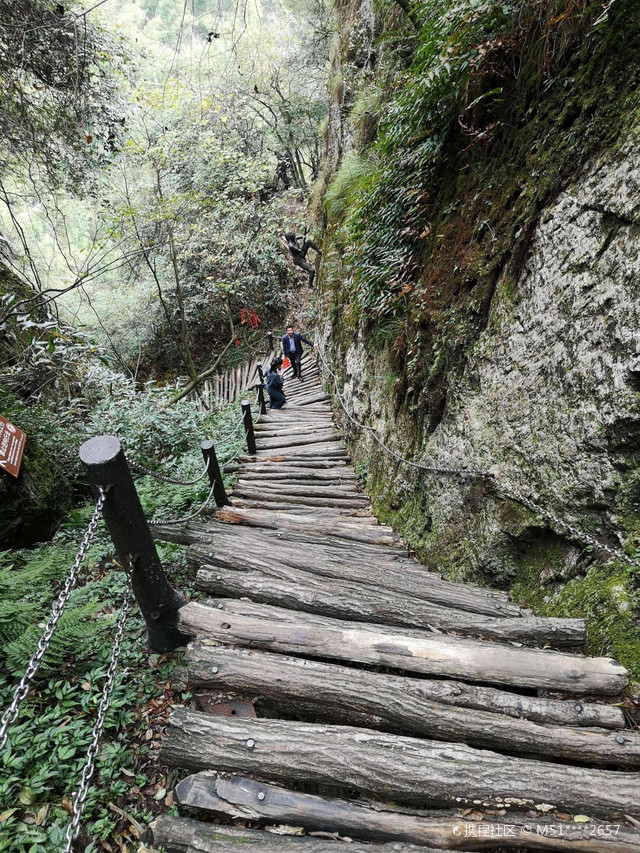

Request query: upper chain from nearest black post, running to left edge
[{"left": 0, "top": 488, "right": 106, "bottom": 750}]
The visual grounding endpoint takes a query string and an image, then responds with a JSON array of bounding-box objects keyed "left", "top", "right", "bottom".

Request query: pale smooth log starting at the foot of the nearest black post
[{"left": 178, "top": 601, "right": 629, "bottom": 695}]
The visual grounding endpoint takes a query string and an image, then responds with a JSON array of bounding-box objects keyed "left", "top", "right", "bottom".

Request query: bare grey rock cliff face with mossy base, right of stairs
[{"left": 316, "top": 0, "right": 640, "bottom": 674}]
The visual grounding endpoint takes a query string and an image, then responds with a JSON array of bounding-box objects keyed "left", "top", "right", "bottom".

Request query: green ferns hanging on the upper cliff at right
[{"left": 326, "top": 0, "right": 620, "bottom": 317}]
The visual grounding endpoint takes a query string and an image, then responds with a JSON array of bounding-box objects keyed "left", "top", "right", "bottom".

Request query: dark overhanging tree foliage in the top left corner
[{"left": 0, "top": 0, "right": 126, "bottom": 189}]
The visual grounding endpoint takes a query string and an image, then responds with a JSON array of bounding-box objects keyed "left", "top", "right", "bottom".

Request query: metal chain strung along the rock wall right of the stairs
[{"left": 317, "top": 347, "right": 638, "bottom": 566}]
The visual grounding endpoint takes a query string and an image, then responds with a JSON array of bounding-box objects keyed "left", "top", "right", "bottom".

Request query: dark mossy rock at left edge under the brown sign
[{"left": 0, "top": 436, "right": 72, "bottom": 549}]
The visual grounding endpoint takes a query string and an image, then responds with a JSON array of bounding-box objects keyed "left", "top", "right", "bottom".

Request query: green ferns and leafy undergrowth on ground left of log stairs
[{"left": 0, "top": 394, "right": 243, "bottom": 853}]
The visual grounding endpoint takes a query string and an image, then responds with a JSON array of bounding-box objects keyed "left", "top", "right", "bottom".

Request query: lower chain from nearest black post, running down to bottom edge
[{"left": 63, "top": 559, "right": 133, "bottom": 853}]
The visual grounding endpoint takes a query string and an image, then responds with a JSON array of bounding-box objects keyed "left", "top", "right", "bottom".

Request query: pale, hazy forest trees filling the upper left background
[{"left": 0, "top": 0, "right": 333, "bottom": 379}]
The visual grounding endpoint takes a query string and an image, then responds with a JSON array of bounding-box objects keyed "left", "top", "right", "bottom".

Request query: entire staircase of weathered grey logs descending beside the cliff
[{"left": 153, "top": 356, "right": 640, "bottom": 853}]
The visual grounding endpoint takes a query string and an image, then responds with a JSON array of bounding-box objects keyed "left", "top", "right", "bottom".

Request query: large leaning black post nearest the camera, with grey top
[{"left": 80, "top": 435, "right": 188, "bottom": 653}]
